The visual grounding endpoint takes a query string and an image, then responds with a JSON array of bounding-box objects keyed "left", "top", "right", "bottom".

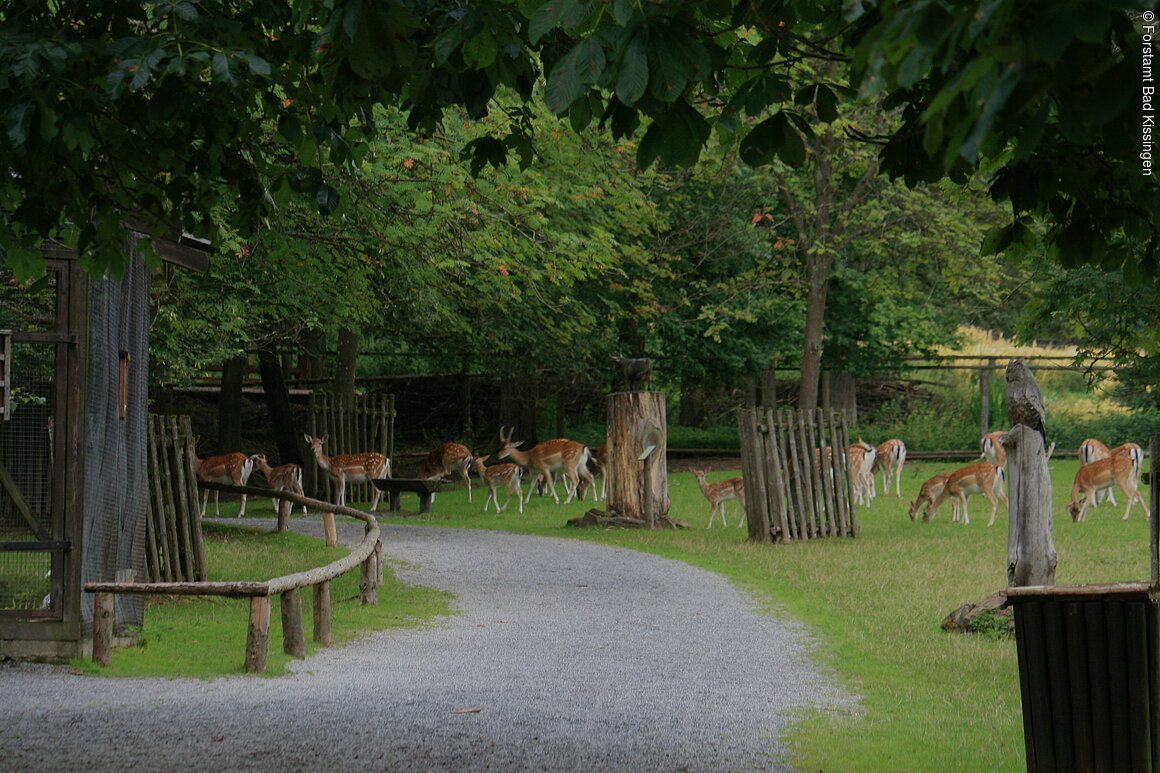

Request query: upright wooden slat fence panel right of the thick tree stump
[{"left": 738, "top": 407, "right": 858, "bottom": 542}]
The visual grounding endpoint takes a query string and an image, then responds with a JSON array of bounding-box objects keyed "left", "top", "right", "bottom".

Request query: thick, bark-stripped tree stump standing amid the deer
[{"left": 607, "top": 392, "right": 669, "bottom": 528}]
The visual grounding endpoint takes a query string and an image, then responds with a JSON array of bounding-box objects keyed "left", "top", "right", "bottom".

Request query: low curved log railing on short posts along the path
[{"left": 85, "top": 484, "right": 383, "bottom": 673}]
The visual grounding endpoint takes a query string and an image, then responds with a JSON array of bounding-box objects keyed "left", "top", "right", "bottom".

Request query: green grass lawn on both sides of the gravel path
[{"left": 84, "top": 460, "right": 1148, "bottom": 773}]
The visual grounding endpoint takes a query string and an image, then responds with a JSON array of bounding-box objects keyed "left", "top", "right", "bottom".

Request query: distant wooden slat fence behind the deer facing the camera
[{"left": 305, "top": 392, "right": 394, "bottom": 501}]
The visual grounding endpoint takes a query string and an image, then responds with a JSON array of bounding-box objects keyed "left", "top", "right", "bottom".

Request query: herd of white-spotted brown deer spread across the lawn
[{"left": 194, "top": 427, "right": 1150, "bottom": 528}]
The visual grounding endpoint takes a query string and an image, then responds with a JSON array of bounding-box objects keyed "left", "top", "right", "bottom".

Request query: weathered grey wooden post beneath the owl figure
[{"left": 1003, "top": 424, "right": 1057, "bottom": 586}]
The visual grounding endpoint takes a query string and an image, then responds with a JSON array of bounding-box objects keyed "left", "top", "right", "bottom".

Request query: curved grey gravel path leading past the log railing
[{"left": 0, "top": 519, "right": 856, "bottom": 773}]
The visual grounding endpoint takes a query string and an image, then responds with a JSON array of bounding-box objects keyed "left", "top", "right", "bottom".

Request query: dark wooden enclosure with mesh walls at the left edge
[{"left": 0, "top": 229, "right": 206, "bottom": 660}]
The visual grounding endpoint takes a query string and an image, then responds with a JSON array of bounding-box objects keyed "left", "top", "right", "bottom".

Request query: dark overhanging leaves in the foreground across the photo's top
[{"left": 0, "top": 0, "right": 1160, "bottom": 280}]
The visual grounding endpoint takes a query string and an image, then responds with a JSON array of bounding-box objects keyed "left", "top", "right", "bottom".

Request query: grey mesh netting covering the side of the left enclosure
[{"left": 81, "top": 239, "right": 148, "bottom": 631}]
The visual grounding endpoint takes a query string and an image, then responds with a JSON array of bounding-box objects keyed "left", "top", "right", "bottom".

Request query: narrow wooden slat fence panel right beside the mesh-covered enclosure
[{"left": 145, "top": 414, "right": 205, "bottom": 583}]
